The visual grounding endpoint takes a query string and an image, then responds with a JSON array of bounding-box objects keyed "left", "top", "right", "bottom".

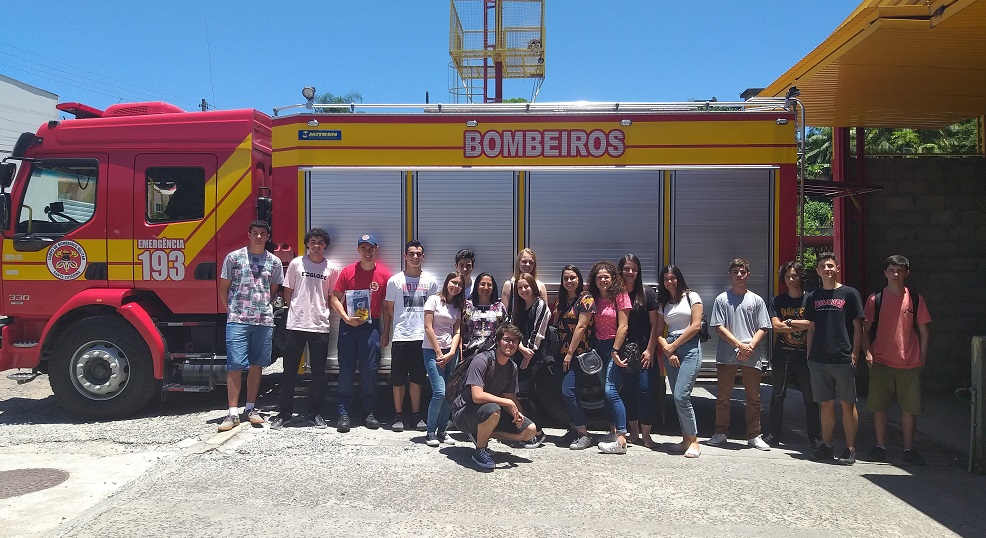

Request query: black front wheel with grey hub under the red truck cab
[{"left": 48, "top": 316, "right": 157, "bottom": 420}]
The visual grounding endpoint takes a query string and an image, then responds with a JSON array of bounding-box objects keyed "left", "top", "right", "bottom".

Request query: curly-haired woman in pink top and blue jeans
[{"left": 566, "top": 261, "right": 632, "bottom": 454}]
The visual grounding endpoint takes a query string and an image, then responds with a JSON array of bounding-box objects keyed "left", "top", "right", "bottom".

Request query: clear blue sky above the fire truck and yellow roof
[{"left": 0, "top": 0, "right": 860, "bottom": 114}]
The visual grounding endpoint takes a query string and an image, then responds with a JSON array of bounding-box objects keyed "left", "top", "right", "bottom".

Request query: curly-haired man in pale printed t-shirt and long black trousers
[{"left": 270, "top": 228, "right": 339, "bottom": 430}]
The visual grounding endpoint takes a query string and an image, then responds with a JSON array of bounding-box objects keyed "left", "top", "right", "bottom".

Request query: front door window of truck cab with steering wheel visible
[{"left": 17, "top": 159, "right": 99, "bottom": 236}]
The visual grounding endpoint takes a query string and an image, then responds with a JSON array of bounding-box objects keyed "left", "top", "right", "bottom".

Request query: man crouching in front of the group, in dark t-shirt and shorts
[{"left": 452, "top": 323, "right": 537, "bottom": 469}]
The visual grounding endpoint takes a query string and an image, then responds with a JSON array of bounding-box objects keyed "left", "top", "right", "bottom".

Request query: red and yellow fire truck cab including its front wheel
[{"left": 0, "top": 103, "right": 272, "bottom": 419}]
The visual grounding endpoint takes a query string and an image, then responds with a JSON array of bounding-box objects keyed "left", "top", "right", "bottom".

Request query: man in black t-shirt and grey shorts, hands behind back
[{"left": 805, "top": 252, "right": 863, "bottom": 465}]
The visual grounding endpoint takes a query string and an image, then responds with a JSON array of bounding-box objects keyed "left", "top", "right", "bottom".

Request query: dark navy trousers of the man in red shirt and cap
[{"left": 336, "top": 319, "right": 380, "bottom": 416}]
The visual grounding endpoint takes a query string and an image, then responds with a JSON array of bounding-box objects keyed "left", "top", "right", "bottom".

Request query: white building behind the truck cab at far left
[{"left": 0, "top": 75, "right": 58, "bottom": 158}]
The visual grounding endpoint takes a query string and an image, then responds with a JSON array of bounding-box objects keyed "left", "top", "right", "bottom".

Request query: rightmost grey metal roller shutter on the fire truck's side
[{"left": 671, "top": 168, "right": 775, "bottom": 370}]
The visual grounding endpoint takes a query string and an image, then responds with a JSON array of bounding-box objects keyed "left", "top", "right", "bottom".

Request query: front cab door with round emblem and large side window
[{"left": 3, "top": 155, "right": 108, "bottom": 317}]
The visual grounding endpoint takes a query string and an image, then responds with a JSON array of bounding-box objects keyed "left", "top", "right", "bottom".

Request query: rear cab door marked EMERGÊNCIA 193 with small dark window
[{"left": 133, "top": 154, "right": 221, "bottom": 314}]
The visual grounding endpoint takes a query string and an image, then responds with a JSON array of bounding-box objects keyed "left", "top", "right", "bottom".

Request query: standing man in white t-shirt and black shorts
[{"left": 380, "top": 239, "right": 438, "bottom": 432}]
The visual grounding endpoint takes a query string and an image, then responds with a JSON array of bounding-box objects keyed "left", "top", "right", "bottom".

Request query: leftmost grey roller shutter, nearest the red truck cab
[{"left": 305, "top": 168, "right": 404, "bottom": 370}]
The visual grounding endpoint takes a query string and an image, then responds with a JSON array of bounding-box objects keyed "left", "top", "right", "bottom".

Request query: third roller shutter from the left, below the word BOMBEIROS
[{"left": 528, "top": 169, "right": 663, "bottom": 288}]
